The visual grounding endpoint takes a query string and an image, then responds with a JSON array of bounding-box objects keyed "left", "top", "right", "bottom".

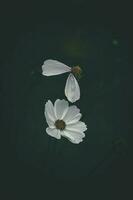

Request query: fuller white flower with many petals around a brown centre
[{"left": 45, "top": 99, "right": 87, "bottom": 144}]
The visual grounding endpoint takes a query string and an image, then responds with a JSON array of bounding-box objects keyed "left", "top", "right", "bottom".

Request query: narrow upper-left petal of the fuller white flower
[{"left": 45, "top": 100, "right": 57, "bottom": 122}]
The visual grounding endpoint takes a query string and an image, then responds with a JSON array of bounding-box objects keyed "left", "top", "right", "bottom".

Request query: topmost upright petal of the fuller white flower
[{"left": 54, "top": 99, "right": 69, "bottom": 119}]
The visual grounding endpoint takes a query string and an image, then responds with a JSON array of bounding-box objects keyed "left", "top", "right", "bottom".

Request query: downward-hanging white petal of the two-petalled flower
[{"left": 65, "top": 73, "right": 80, "bottom": 103}]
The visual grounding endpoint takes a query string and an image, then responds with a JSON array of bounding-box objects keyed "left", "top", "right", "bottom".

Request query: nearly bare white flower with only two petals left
[{"left": 42, "top": 59, "right": 81, "bottom": 103}]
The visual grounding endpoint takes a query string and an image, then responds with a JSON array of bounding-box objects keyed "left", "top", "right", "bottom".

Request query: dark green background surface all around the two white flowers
[{"left": 0, "top": 1, "right": 131, "bottom": 199}]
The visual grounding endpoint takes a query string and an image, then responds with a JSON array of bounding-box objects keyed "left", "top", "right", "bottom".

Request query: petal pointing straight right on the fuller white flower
[{"left": 66, "top": 121, "right": 87, "bottom": 132}]
